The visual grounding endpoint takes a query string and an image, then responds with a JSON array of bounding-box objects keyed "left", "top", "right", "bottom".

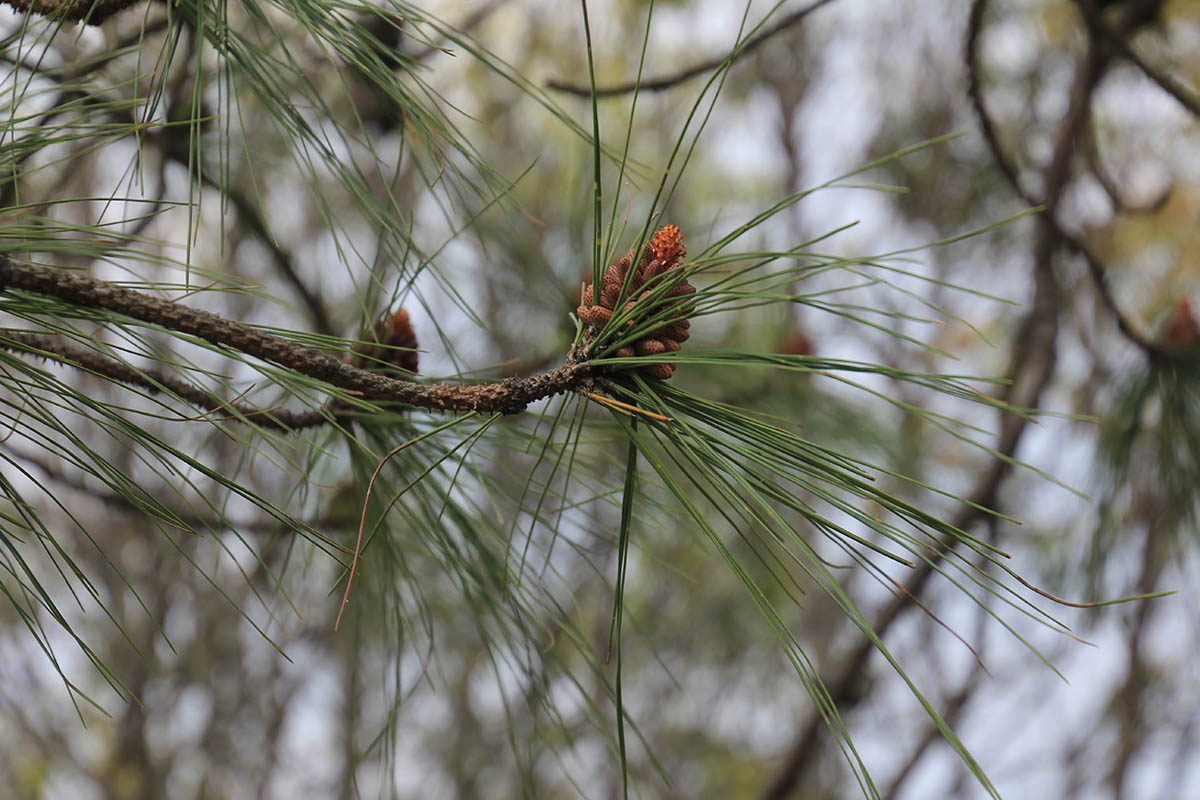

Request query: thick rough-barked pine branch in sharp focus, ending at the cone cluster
[{"left": 0, "top": 255, "right": 594, "bottom": 416}]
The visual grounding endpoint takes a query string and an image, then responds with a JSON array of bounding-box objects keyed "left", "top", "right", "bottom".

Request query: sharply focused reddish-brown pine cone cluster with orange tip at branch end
[{"left": 576, "top": 225, "right": 696, "bottom": 380}]
